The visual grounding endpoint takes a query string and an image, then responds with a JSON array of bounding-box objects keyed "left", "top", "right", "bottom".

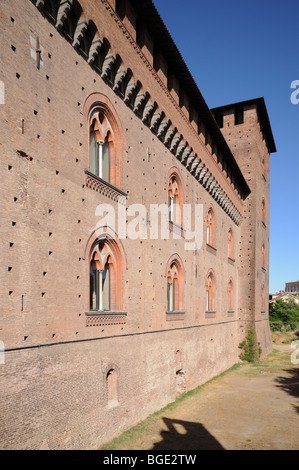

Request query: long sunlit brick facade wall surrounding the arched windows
[{"left": 0, "top": 0, "right": 268, "bottom": 449}]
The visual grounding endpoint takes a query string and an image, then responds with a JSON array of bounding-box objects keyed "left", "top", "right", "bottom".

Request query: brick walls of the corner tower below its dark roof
[{"left": 222, "top": 105, "right": 272, "bottom": 356}]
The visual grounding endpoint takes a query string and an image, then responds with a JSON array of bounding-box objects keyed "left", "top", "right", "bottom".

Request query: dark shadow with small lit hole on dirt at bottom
[{"left": 151, "top": 418, "right": 225, "bottom": 450}]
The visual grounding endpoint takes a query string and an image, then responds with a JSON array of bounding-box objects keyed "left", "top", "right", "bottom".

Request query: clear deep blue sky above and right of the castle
[{"left": 153, "top": 0, "right": 299, "bottom": 293}]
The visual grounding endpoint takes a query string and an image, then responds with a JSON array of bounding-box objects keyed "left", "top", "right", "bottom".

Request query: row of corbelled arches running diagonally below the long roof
[{"left": 31, "top": 0, "right": 242, "bottom": 225}]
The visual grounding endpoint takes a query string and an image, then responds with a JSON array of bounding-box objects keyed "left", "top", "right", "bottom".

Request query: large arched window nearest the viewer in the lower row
[{"left": 89, "top": 236, "right": 123, "bottom": 312}]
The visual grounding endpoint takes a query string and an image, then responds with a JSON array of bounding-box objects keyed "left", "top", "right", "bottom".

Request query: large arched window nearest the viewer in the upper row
[{"left": 89, "top": 112, "right": 113, "bottom": 183}]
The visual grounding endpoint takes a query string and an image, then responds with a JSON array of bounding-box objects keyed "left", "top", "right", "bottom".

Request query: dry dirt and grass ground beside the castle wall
[{"left": 102, "top": 345, "right": 299, "bottom": 450}]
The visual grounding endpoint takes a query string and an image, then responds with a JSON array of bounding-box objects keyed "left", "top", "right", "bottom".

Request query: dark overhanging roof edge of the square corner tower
[{"left": 211, "top": 97, "right": 276, "bottom": 153}]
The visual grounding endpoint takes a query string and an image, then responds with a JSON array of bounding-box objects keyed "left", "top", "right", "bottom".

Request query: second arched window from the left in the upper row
[{"left": 168, "top": 168, "right": 185, "bottom": 226}]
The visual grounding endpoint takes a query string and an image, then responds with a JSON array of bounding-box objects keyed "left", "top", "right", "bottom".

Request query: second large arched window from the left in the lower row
[{"left": 167, "top": 257, "right": 183, "bottom": 312}]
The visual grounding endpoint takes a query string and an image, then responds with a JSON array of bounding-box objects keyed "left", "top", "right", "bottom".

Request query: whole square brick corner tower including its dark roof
[{"left": 211, "top": 98, "right": 276, "bottom": 357}]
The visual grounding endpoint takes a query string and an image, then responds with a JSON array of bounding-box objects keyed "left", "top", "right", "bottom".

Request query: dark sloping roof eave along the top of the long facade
[{"left": 132, "top": 0, "right": 251, "bottom": 197}]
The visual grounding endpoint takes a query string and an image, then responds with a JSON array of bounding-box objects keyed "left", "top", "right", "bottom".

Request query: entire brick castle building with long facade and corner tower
[{"left": 0, "top": 0, "right": 276, "bottom": 449}]
